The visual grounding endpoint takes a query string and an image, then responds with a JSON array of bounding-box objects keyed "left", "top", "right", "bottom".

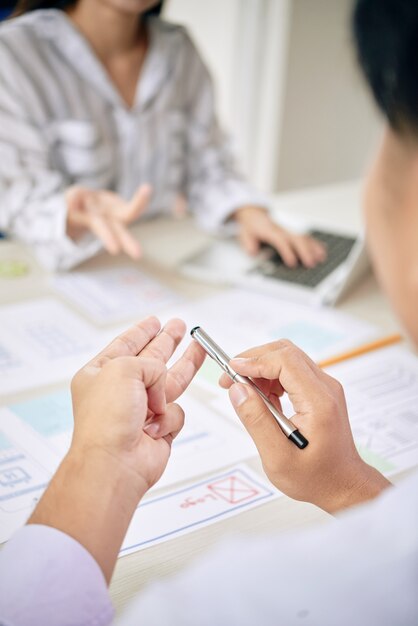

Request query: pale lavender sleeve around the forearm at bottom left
[{"left": 0, "top": 524, "right": 113, "bottom": 626}]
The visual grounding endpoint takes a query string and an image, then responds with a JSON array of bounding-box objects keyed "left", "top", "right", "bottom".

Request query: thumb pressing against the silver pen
[{"left": 229, "top": 383, "right": 288, "bottom": 454}]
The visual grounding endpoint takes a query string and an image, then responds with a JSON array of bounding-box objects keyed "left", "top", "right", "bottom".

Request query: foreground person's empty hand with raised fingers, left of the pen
[{"left": 72, "top": 317, "right": 205, "bottom": 492}]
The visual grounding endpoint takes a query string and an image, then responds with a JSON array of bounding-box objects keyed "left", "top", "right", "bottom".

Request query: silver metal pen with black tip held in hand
[{"left": 190, "top": 326, "right": 309, "bottom": 449}]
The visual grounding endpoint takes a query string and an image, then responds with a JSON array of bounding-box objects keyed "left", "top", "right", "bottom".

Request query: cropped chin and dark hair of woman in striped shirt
[{"left": 13, "top": 0, "right": 163, "bottom": 17}]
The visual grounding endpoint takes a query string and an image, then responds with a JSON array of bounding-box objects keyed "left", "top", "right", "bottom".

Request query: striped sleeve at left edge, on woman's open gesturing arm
[{"left": 0, "top": 42, "right": 101, "bottom": 269}]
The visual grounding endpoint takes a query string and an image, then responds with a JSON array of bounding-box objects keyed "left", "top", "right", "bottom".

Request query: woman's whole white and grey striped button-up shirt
[{"left": 0, "top": 9, "right": 266, "bottom": 269}]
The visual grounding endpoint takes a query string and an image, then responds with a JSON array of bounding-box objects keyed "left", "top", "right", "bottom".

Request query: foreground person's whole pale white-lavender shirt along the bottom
[{"left": 0, "top": 474, "right": 418, "bottom": 626}]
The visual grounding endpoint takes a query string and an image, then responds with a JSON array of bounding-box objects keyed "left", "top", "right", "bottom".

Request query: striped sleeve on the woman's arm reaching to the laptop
[{"left": 180, "top": 34, "right": 268, "bottom": 231}]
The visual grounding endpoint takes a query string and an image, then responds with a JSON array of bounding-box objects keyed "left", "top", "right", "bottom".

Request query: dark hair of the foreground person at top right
[{"left": 352, "top": 0, "right": 418, "bottom": 135}]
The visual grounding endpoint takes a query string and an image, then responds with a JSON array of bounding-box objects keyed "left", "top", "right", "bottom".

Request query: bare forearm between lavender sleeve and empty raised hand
[{"left": 28, "top": 450, "right": 145, "bottom": 583}]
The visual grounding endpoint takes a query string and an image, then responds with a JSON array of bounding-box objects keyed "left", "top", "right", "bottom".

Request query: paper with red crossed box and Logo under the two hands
[{"left": 120, "top": 467, "right": 282, "bottom": 556}]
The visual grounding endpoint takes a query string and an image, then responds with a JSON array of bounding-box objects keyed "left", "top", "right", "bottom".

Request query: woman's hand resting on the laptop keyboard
[{"left": 234, "top": 206, "right": 326, "bottom": 267}]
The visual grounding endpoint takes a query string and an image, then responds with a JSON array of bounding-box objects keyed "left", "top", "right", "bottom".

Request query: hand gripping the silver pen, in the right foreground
[{"left": 220, "top": 340, "right": 390, "bottom": 513}]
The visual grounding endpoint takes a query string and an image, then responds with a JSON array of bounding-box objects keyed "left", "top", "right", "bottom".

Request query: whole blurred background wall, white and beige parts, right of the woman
[{"left": 165, "top": 0, "right": 381, "bottom": 191}]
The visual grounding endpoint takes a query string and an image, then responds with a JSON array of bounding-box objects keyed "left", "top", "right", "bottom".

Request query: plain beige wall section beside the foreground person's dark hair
[{"left": 275, "top": 0, "right": 381, "bottom": 189}]
